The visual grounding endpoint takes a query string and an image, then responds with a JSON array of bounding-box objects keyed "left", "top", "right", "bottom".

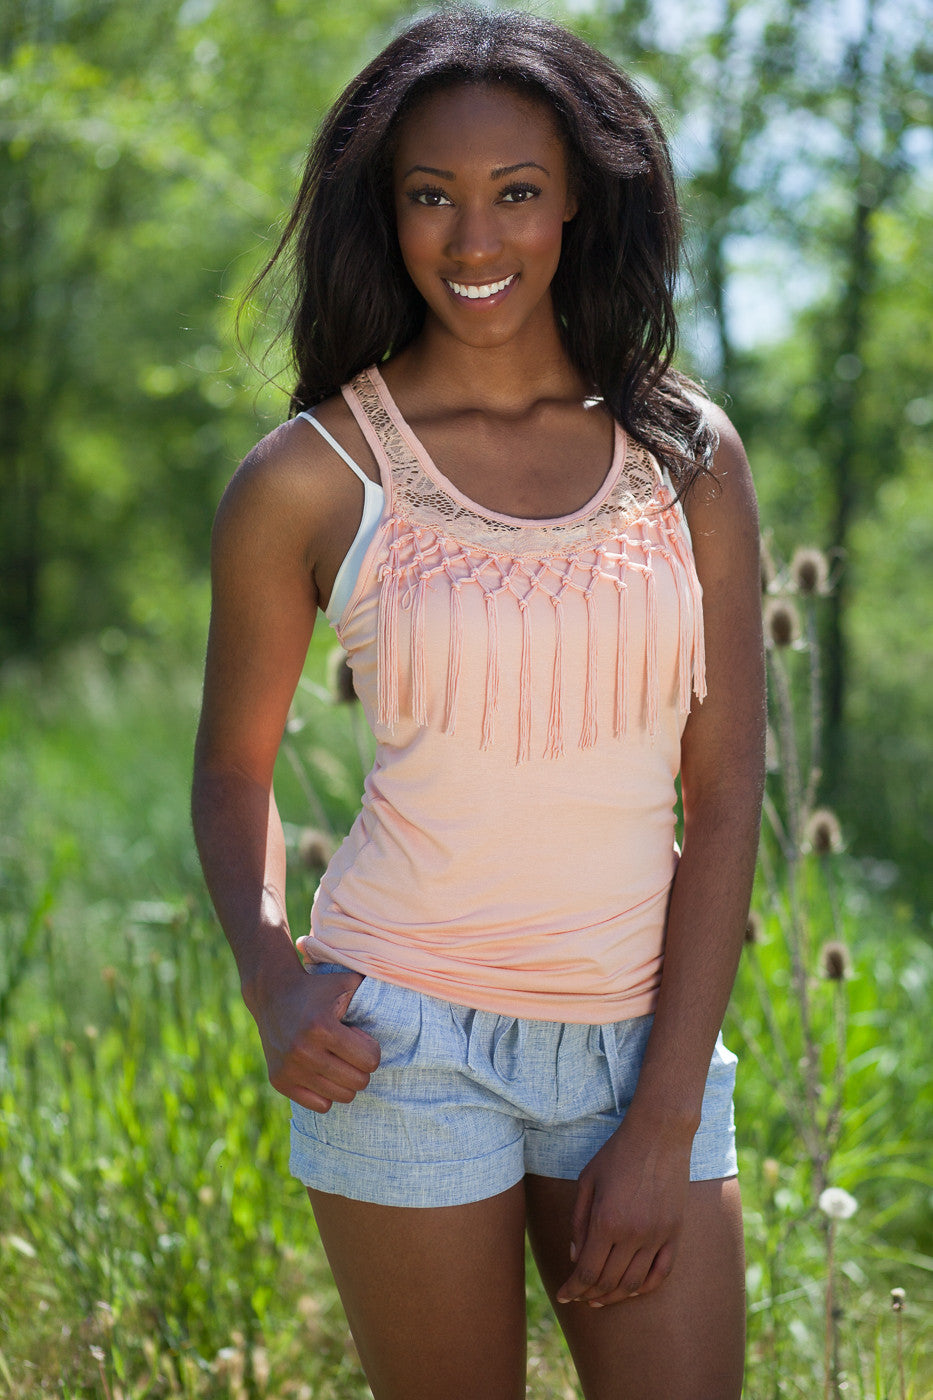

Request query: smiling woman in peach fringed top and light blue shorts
[{"left": 193, "top": 10, "right": 763, "bottom": 1400}]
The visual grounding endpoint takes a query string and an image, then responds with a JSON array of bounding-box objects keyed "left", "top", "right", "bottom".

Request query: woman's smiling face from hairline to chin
[{"left": 394, "top": 85, "right": 576, "bottom": 347}]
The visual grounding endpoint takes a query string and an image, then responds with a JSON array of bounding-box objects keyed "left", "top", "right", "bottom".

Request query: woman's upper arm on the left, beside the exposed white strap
[{"left": 195, "top": 426, "right": 321, "bottom": 785}]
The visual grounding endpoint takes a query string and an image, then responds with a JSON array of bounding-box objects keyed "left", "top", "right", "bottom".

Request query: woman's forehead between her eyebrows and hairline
[{"left": 395, "top": 83, "right": 563, "bottom": 174}]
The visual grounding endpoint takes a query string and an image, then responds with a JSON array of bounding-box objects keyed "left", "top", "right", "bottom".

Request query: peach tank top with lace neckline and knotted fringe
[{"left": 301, "top": 368, "right": 705, "bottom": 1025}]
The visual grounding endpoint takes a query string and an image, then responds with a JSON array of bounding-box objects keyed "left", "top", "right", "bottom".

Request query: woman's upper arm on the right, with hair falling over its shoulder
[{"left": 681, "top": 405, "right": 765, "bottom": 820}]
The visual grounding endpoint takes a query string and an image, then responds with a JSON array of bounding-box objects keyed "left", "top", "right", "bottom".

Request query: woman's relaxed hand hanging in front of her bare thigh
[{"left": 558, "top": 1110, "right": 691, "bottom": 1308}]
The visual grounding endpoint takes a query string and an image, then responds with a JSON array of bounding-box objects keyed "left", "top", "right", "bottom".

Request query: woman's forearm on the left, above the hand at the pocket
[{"left": 192, "top": 769, "right": 298, "bottom": 1009}]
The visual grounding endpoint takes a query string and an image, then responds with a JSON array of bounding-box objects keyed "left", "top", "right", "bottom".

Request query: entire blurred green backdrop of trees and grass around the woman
[{"left": 0, "top": 0, "right": 933, "bottom": 1400}]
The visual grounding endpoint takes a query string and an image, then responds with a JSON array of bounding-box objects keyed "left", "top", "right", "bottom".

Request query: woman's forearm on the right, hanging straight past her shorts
[{"left": 624, "top": 784, "right": 759, "bottom": 1137}]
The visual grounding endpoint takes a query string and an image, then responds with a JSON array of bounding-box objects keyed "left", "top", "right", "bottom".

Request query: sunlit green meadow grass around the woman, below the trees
[{"left": 0, "top": 636, "right": 933, "bottom": 1400}]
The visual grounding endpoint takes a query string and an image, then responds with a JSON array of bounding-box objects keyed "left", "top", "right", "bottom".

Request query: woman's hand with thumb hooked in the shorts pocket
[{"left": 249, "top": 960, "right": 380, "bottom": 1113}]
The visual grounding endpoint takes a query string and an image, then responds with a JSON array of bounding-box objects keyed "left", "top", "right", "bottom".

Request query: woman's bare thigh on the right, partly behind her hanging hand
[{"left": 525, "top": 1176, "right": 745, "bottom": 1400}]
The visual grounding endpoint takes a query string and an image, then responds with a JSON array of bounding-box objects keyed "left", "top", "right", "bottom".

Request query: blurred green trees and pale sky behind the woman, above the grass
[{"left": 0, "top": 0, "right": 933, "bottom": 920}]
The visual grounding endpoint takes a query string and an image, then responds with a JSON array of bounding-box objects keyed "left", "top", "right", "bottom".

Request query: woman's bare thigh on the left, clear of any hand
[{"left": 308, "top": 1183, "right": 525, "bottom": 1400}]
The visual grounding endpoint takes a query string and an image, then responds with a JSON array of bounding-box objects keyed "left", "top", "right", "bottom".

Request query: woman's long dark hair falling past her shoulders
[{"left": 248, "top": 6, "right": 716, "bottom": 494}]
